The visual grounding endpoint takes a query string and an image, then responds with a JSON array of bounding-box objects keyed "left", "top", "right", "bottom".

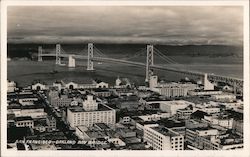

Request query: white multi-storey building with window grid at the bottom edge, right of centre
[{"left": 143, "top": 125, "right": 184, "bottom": 150}]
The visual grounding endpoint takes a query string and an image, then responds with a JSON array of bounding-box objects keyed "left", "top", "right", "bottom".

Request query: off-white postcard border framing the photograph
[{"left": 1, "top": 0, "right": 250, "bottom": 157}]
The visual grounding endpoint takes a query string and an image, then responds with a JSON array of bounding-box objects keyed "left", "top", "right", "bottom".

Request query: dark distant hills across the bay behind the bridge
[{"left": 7, "top": 44, "right": 243, "bottom": 58}]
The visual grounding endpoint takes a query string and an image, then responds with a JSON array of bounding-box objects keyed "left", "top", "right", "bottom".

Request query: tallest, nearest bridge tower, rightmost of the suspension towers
[{"left": 145, "top": 45, "right": 154, "bottom": 82}]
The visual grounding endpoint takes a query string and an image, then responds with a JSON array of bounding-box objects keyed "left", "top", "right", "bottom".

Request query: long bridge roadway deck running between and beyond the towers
[{"left": 41, "top": 54, "right": 243, "bottom": 90}]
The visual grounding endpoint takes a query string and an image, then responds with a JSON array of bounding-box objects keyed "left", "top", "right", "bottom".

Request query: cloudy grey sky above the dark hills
[{"left": 7, "top": 6, "right": 243, "bottom": 45}]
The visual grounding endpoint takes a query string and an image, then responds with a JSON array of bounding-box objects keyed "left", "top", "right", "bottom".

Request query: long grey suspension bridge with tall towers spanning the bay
[{"left": 38, "top": 43, "right": 243, "bottom": 93}]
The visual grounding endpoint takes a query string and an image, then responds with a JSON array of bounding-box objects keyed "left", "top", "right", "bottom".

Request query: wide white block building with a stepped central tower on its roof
[{"left": 67, "top": 95, "right": 115, "bottom": 128}]
